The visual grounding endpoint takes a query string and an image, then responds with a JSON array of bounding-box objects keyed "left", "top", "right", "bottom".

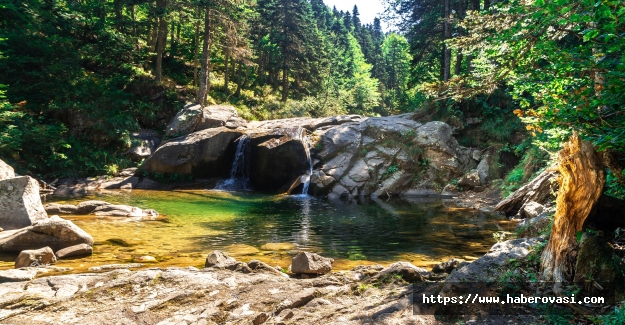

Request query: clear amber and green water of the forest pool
[{"left": 0, "top": 190, "right": 502, "bottom": 272}]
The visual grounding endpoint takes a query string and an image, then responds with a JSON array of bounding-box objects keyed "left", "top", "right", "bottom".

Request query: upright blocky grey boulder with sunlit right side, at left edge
[{"left": 0, "top": 176, "right": 48, "bottom": 230}]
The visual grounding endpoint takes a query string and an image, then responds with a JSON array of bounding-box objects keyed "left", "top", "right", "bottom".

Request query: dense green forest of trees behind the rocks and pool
[{"left": 0, "top": 0, "right": 625, "bottom": 201}]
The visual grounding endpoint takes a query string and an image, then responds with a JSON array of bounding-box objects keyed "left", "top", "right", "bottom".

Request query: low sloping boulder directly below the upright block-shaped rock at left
[{"left": 0, "top": 216, "right": 93, "bottom": 252}]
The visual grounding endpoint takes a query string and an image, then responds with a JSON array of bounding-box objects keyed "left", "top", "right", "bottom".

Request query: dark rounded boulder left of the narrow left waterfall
[{"left": 141, "top": 127, "right": 242, "bottom": 177}]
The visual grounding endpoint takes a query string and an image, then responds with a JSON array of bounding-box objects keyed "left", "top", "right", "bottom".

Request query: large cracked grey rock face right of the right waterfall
[{"left": 311, "top": 116, "right": 470, "bottom": 199}]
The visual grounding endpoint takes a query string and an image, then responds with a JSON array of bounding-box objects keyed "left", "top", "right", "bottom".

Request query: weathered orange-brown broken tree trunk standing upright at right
[{"left": 541, "top": 133, "right": 605, "bottom": 295}]
